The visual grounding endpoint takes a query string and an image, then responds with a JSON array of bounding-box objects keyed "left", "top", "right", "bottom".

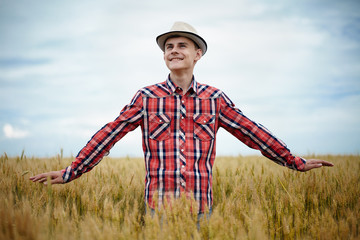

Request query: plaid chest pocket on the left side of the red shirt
[{"left": 149, "top": 114, "right": 171, "bottom": 141}]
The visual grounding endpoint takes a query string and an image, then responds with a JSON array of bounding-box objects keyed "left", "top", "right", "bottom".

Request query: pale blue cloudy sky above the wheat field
[{"left": 0, "top": 0, "right": 360, "bottom": 157}]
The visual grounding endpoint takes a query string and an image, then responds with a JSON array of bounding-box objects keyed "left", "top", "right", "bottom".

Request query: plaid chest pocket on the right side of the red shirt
[{"left": 194, "top": 114, "right": 215, "bottom": 141}]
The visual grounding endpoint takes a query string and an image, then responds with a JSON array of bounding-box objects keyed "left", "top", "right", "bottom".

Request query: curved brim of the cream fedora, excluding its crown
[{"left": 156, "top": 31, "right": 207, "bottom": 55}]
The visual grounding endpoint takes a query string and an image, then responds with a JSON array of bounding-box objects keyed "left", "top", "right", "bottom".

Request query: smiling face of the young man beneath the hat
[{"left": 164, "top": 37, "right": 202, "bottom": 71}]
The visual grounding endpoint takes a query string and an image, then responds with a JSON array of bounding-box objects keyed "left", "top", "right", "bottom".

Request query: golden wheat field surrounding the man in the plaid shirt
[{"left": 0, "top": 154, "right": 360, "bottom": 239}]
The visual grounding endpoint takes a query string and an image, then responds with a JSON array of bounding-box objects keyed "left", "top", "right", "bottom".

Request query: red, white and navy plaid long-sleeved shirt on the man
[{"left": 63, "top": 78, "right": 305, "bottom": 212}]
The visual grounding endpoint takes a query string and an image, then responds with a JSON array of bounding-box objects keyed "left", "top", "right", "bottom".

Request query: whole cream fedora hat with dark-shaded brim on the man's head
[{"left": 156, "top": 22, "right": 207, "bottom": 55}]
